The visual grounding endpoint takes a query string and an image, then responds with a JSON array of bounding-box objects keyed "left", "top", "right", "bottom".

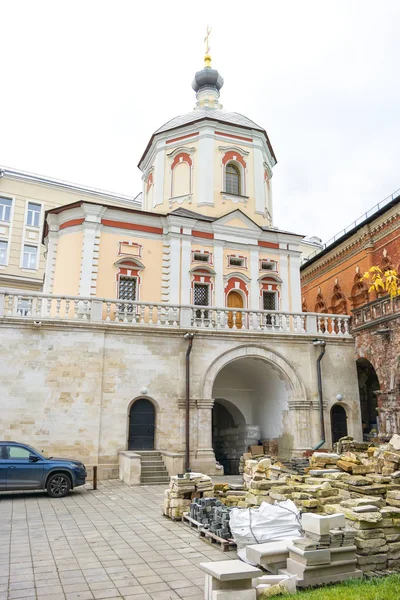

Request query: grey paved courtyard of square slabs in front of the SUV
[{"left": 0, "top": 480, "right": 235, "bottom": 600}]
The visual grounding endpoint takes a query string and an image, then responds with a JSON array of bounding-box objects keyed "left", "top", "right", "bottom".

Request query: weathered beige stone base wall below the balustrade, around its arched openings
[{"left": 0, "top": 319, "right": 361, "bottom": 471}]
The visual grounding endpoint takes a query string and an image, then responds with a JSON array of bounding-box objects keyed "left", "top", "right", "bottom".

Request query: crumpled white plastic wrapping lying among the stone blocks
[{"left": 229, "top": 500, "right": 301, "bottom": 548}]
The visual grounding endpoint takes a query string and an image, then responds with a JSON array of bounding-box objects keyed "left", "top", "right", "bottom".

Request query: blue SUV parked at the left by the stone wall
[{"left": 0, "top": 442, "right": 86, "bottom": 498}]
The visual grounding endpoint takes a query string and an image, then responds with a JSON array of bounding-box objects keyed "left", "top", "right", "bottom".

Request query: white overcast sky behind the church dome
[{"left": 0, "top": 0, "right": 400, "bottom": 241}]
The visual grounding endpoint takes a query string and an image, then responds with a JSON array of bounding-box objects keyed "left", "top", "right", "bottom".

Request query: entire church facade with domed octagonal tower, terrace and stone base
[{"left": 0, "top": 57, "right": 361, "bottom": 476}]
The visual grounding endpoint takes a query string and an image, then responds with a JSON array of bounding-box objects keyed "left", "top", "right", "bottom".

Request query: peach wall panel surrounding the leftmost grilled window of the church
[{"left": 96, "top": 230, "right": 163, "bottom": 302}]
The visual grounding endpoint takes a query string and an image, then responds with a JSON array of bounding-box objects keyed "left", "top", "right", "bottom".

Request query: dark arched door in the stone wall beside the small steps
[{"left": 128, "top": 398, "right": 156, "bottom": 450}]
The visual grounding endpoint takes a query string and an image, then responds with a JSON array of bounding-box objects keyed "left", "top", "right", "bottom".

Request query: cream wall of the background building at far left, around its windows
[{"left": 0, "top": 176, "right": 141, "bottom": 291}]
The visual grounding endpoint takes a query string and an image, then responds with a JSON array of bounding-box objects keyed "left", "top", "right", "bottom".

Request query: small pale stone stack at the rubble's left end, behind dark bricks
[{"left": 163, "top": 473, "right": 214, "bottom": 520}]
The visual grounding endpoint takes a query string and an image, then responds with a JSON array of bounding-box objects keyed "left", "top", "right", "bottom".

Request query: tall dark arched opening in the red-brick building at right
[{"left": 357, "top": 358, "right": 380, "bottom": 439}]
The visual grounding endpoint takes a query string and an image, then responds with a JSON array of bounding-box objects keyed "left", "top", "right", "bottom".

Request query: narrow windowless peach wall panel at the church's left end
[{"left": 53, "top": 231, "right": 83, "bottom": 296}]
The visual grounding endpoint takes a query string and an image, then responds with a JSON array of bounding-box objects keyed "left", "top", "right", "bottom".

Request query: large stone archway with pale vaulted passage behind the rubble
[{"left": 203, "top": 345, "right": 311, "bottom": 460}]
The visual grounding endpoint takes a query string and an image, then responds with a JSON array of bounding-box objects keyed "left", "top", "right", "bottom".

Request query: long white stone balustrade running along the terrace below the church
[{"left": 0, "top": 288, "right": 350, "bottom": 337}]
